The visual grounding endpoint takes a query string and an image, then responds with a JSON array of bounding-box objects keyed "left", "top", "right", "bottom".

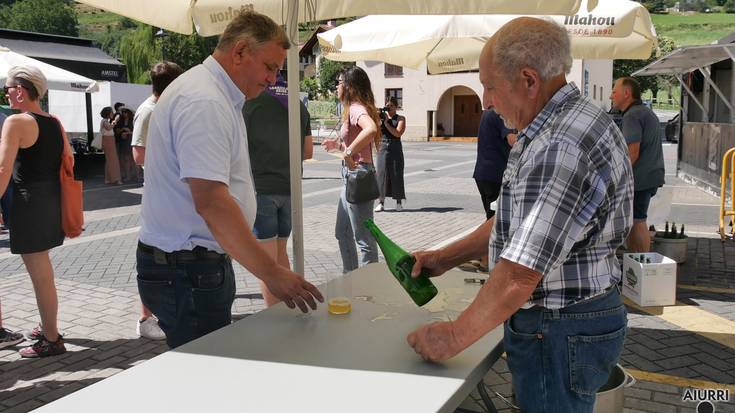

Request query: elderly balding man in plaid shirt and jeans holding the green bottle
[{"left": 408, "top": 17, "right": 633, "bottom": 413}]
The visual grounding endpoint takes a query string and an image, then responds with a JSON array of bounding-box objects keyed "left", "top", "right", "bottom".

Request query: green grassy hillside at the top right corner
[{"left": 651, "top": 13, "right": 735, "bottom": 46}]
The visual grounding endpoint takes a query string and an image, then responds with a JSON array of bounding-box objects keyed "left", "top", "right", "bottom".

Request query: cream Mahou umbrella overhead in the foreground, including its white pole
[{"left": 77, "top": 0, "right": 597, "bottom": 274}]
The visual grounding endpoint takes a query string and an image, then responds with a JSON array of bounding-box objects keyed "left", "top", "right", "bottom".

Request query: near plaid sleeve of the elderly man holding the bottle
[{"left": 500, "top": 143, "right": 605, "bottom": 274}]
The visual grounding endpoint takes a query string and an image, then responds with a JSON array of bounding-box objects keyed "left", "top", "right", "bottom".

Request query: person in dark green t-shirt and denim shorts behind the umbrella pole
[{"left": 242, "top": 79, "right": 313, "bottom": 307}]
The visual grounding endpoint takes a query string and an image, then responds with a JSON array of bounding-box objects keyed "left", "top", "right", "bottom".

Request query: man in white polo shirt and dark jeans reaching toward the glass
[{"left": 136, "top": 12, "right": 323, "bottom": 348}]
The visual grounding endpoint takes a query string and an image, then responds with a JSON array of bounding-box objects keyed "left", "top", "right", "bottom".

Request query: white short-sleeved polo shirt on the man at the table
[{"left": 139, "top": 56, "right": 257, "bottom": 252}]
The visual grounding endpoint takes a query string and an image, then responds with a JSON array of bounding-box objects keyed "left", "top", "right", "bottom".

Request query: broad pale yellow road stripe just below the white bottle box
[{"left": 625, "top": 298, "right": 735, "bottom": 349}]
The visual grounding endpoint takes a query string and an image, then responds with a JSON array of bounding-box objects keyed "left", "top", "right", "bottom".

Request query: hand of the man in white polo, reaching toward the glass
[{"left": 263, "top": 265, "right": 324, "bottom": 313}]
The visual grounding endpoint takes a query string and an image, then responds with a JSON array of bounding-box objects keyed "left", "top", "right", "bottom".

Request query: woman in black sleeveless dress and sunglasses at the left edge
[{"left": 0, "top": 66, "right": 71, "bottom": 357}]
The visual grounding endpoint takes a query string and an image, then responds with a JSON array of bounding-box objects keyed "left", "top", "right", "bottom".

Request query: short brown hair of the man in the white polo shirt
[{"left": 217, "top": 10, "right": 291, "bottom": 51}]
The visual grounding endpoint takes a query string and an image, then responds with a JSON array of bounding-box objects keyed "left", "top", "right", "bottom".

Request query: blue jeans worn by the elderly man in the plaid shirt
[{"left": 503, "top": 286, "right": 627, "bottom": 413}]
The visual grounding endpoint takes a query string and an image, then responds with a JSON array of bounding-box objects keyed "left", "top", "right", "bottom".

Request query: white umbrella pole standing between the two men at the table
[{"left": 286, "top": 0, "right": 304, "bottom": 275}]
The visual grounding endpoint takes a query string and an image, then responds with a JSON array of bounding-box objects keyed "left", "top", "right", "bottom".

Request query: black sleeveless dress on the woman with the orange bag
[{"left": 10, "top": 112, "right": 64, "bottom": 254}]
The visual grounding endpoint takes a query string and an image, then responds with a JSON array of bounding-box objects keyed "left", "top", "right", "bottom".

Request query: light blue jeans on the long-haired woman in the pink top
[{"left": 334, "top": 164, "right": 378, "bottom": 273}]
